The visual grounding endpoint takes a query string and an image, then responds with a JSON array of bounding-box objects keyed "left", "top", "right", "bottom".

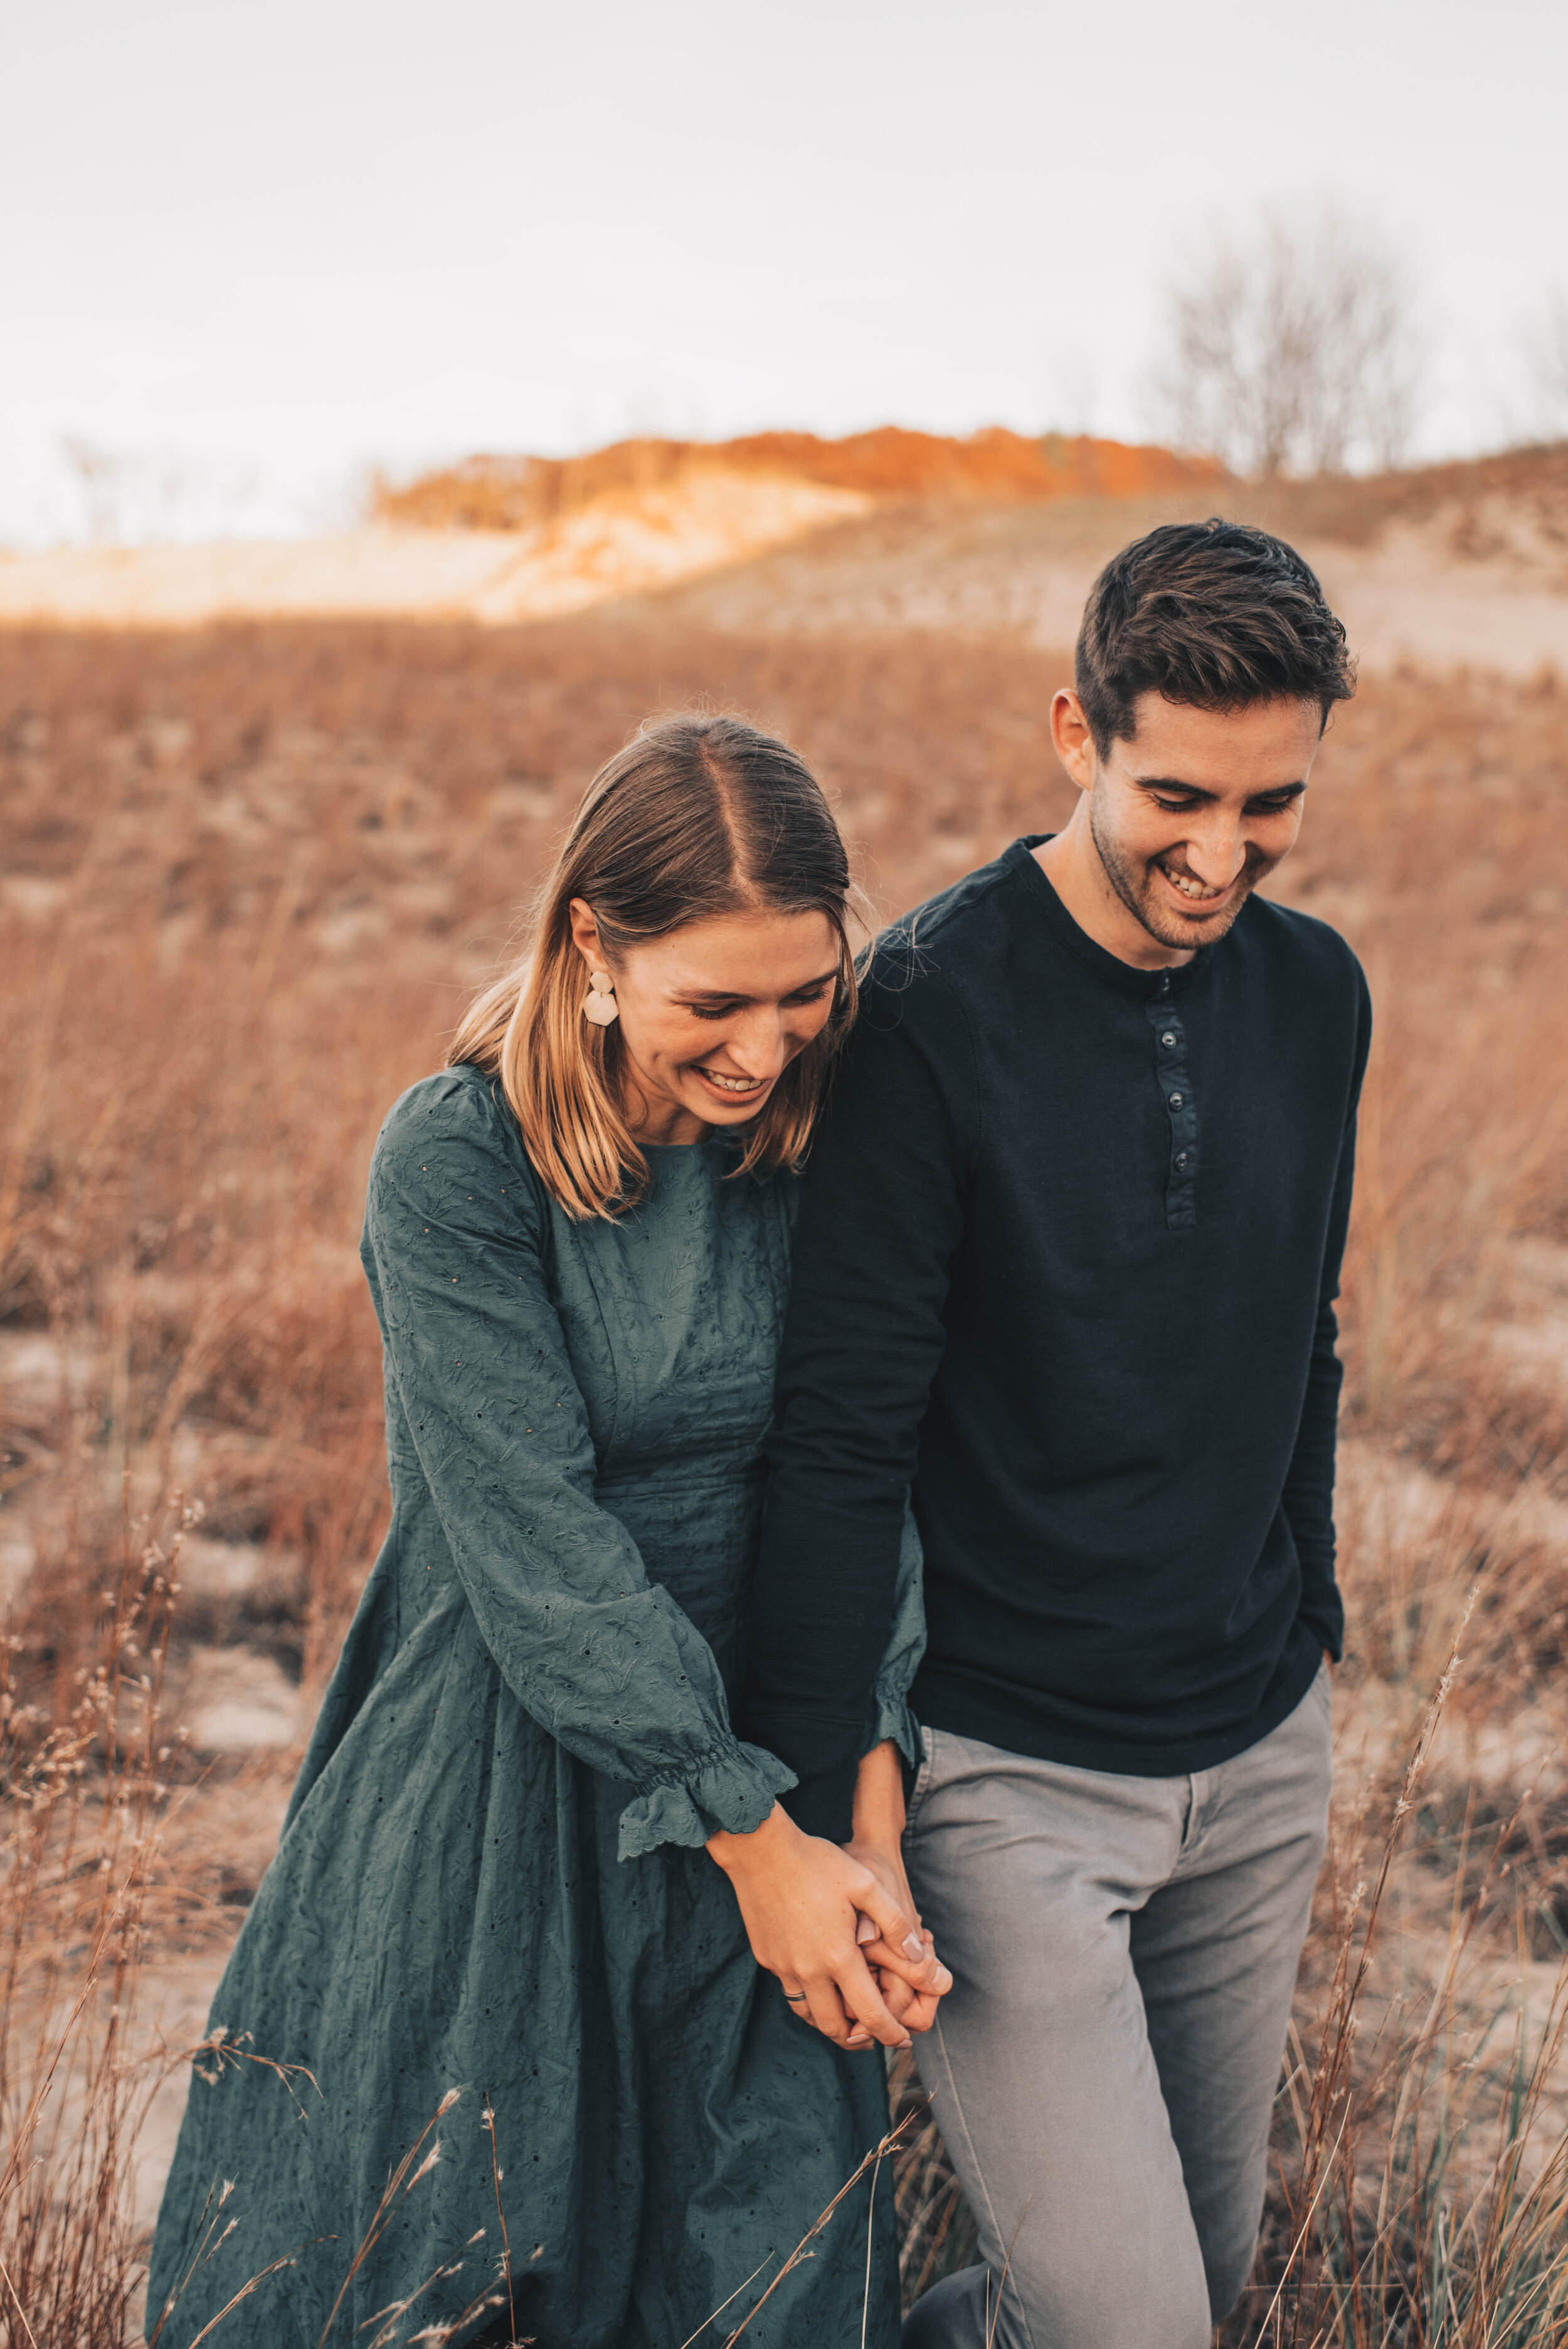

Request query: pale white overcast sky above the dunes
[{"left": 0, "top": 0, "right": 1568, "bottom": 545}]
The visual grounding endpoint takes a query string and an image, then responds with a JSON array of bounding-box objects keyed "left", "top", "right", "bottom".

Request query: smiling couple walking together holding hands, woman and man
[{"left": 148, "top": 521, "right": 1369, "bottom": 2349}]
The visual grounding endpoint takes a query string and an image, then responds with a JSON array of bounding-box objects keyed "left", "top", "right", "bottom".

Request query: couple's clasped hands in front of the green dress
[{"left": 709, "top": 1746, "right": 953, "bottom": 2049}]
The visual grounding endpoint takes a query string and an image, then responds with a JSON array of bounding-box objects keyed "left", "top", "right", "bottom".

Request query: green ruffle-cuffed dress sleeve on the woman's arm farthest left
[{"left": 361, "top": 1071, "right": 793, "bottom": 1858}]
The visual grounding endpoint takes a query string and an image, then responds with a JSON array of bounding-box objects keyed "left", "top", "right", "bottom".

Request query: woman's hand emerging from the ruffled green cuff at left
[{"left": 706, "top": 1804, "right": 932, "bottom": 2049}]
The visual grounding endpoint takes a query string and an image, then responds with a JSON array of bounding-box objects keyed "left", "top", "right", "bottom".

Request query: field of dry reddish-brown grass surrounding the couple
[{"left": 0, "top": 620, "right": 1568, "bottom": 2349}]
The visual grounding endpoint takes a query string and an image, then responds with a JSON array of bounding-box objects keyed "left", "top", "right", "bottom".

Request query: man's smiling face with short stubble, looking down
[{"left": 1056, "top": 693, "right": 1322, "bottom": 961}]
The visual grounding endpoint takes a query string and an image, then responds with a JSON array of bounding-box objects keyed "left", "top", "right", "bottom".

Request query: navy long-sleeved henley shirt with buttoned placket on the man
[{"left": 744, "top": 839, "right": 1371, "bottom": 1839}]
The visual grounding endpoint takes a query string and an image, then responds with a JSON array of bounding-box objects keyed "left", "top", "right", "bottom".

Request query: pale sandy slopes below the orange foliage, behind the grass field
[{"left": 0, "top": 472, "right": 1568, "bottom": 677}]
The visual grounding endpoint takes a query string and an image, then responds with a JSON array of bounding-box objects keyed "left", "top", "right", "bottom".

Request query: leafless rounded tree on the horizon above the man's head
[{"left": 1160, "top": 202, "right": 1420, "bottom": 477}]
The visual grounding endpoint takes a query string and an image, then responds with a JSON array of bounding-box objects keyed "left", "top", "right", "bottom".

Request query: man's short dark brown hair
[{"left": 1075, "top": 514, "right": 1357, "bottom": 759}]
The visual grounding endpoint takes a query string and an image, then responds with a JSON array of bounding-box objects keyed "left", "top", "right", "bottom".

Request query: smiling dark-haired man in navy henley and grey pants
[{"left": 749, "top": 521, "right": 1371, "bottom": 2349}]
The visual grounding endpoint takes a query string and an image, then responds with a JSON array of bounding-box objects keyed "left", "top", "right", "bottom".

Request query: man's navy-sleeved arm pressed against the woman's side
[{"left": 742, "top": 970, "right": 979, "bottom": 1842}]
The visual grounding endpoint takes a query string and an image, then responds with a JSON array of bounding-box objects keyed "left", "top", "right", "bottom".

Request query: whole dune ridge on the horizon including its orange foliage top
[{"left": 0, "top": 432, "right": 1568, "bottom": 677}]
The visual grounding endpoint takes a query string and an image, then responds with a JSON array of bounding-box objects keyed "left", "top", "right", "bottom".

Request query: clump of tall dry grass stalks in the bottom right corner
[{"left": 1227, "top": 1590, "right": 1568, "bottom": 2349}]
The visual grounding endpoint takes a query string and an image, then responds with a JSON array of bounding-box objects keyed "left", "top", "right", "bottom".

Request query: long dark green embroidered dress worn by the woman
[{"left": 148, "top": 1069, "right": 906, "bottom": 2349}]
